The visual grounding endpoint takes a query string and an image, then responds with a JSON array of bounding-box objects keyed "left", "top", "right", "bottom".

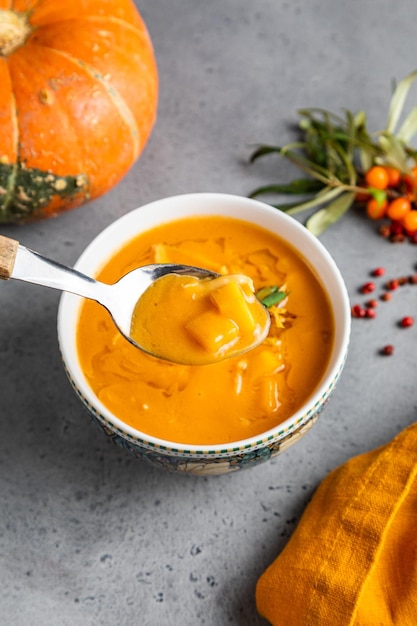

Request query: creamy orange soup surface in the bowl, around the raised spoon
[{"left": 77, "top": 216, "right": 334, "bottom": 445}]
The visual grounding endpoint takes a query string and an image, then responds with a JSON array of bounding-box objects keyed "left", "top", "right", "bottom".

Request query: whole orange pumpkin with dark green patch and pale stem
[{"left": 0, "top": 0, "right": 158, "bottom": 222}]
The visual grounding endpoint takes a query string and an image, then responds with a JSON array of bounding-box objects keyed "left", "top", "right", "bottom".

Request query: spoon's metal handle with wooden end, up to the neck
[{"left": 0, "top": 235, "right": 108, "bottom": 302}]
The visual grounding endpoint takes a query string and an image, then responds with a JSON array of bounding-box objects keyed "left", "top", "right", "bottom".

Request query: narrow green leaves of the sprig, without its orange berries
[{"left": 250, "top": 70, "right": 417, "bottom": 236}]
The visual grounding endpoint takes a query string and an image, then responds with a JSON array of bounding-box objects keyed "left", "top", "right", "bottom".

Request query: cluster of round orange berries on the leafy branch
[{"left": 356, "top": 165, "right": 417, "bottom": 243}]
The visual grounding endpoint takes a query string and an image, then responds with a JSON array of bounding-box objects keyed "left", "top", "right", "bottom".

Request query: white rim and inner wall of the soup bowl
[{"left": 58, "top": 193, "right": 350, "bottom": 451}]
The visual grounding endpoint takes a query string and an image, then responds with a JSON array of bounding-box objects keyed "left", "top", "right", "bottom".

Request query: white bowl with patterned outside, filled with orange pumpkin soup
[{"left": 58, "top": 193, "right": 350, "bottom": 475}]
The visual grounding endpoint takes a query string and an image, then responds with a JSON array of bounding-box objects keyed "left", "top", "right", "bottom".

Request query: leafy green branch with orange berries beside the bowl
[{"left": 250, "top": 70, "right": 417, "bottom": 243}]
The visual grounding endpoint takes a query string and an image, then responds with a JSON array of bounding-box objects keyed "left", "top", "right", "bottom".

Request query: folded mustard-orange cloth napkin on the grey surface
[{"left": 256, "top": 423, "right": 417, "bottom": 626}]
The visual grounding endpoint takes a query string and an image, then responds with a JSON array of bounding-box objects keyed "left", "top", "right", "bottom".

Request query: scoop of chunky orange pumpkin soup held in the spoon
[{"left": 130, "top": 273, "right": 270, "bottom": 365}]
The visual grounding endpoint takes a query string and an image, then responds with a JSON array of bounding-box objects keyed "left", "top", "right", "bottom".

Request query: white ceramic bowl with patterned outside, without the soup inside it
[{"left": 58, "top": 193, "right": 350, "bottom": 475}]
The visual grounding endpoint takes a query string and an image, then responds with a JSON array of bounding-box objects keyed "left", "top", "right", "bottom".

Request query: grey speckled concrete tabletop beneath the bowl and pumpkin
[{"left": 0, "top": 0, "right": 417, "bottom": 626}]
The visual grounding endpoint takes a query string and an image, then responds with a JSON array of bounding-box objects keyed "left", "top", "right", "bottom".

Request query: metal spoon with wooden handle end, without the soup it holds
[{"left": 0, "top": 235, "right": 263, "bottom": 364}]
